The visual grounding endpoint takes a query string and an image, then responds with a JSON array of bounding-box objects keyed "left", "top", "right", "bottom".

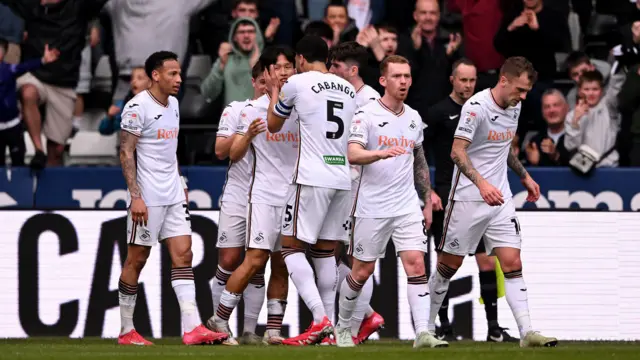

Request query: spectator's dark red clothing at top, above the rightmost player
[{"left": 447, "top": 0, "right": 504, "bottom": 91}]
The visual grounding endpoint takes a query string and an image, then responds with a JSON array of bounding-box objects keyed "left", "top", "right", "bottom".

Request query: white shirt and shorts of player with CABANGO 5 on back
[{"left": 273, "top": 71, "right": 356, "bottom": 244}]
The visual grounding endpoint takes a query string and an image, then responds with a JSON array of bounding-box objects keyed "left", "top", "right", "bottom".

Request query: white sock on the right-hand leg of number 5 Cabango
[{"left": 309, "top": 249, "right": 338, "bottom": 324}]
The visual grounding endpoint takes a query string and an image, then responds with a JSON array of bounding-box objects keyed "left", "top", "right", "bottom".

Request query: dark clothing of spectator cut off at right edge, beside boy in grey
[{"left": 618, "top": 65, "right": 640, "bottom": 166}]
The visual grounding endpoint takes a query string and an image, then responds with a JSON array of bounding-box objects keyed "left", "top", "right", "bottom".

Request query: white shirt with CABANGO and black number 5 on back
[{"left": 273, "top": 71, "right": 356, "bottom": 190}]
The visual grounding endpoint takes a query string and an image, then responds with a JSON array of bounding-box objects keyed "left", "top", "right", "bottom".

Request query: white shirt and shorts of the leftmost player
[{"left": 120, "top": 91, "right": 191, "bottom": 246}]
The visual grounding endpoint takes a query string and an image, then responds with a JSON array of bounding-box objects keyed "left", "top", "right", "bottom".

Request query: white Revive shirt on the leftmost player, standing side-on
[{"left": 120, "top": 90, "right": 185, "bottom": 206}]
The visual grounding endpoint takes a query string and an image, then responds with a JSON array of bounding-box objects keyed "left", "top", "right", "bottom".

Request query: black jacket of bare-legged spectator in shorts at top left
[{"left": 0, "top": 0, "right": 108, "bottom": 88}]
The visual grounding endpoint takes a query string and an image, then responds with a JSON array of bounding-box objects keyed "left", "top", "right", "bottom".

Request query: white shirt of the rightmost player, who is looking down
[{"left": 449, "top": 89, "right": 522, "bottom": 201}]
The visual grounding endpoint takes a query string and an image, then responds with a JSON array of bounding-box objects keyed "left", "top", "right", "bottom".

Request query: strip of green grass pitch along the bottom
[{"left": 0, "top": 338, "right": 640, "bottom": 360}]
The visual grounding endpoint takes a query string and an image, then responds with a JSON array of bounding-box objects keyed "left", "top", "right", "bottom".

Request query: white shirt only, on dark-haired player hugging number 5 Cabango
[{"left": 237, "top": 95, "right": 300, "bottom": 206}]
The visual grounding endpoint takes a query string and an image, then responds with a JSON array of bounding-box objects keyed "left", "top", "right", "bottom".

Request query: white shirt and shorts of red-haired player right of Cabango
[{"left": 349, "top": 100, "right": 428, "bottom": 262}]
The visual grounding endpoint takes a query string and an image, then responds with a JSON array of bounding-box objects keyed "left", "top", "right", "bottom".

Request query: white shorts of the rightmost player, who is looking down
[{"left": 438, "top": 198, "right": 522, "bottom": 256}]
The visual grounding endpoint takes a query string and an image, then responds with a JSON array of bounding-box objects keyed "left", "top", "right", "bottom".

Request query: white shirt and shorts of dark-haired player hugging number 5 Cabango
[{"left": 237, "top": 95, "right": 300, "bottom": 252}]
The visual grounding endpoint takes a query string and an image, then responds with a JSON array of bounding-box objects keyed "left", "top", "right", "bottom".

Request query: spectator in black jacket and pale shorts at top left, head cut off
[{"left": 0, "top": 0, "right": 109, "bottom": 170}]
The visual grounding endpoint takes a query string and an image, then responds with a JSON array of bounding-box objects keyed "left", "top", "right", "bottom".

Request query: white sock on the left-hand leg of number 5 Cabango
[{"left": 282, "top": 248, "right": 326, "bottom": 323}]
